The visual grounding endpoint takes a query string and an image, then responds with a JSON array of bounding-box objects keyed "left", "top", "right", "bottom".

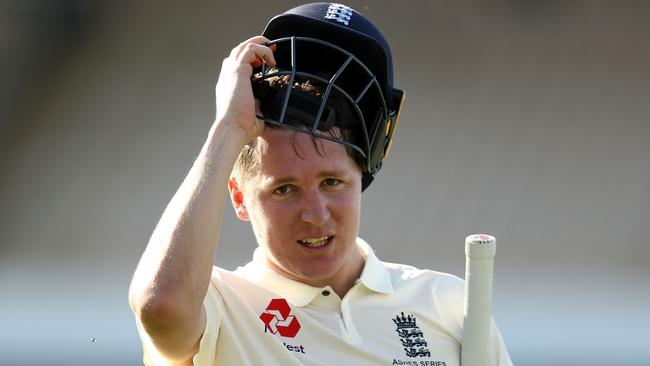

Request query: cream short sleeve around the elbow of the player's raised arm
[{"left": 136, "top": 278, "right": 223, "bottom": 366}]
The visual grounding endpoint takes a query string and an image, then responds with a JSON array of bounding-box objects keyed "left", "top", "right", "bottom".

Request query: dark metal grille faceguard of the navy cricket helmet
[{"left": 252, "top": 37, "right": 404, "bottom": 190}]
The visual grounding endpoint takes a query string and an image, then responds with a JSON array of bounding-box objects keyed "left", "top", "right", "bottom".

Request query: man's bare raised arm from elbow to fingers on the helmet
[{"left": 129, "top": 36, "right": 275, "bottom": 364}]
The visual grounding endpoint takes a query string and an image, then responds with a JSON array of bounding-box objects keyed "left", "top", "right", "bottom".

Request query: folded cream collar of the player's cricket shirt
[{"left": 236, "top": 238, "right": 393, "bottom": 306}]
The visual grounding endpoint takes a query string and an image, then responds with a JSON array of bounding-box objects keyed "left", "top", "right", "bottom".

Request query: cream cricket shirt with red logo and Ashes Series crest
[{"left": 138, "top": 239, "right": 512, "bottom": 366}]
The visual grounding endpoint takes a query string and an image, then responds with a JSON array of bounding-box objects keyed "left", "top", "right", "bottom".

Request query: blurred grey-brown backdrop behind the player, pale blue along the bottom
[{"left": 0, "top": 0, "right": 650, "bottom": 366}]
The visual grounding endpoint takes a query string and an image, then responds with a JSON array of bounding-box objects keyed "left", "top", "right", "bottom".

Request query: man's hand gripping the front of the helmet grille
[{"left": 215, "top": 36, "right": 275, "bottom": 142}]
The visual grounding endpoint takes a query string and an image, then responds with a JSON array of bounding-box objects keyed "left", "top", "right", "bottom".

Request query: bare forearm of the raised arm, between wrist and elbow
[{"left": 129, "top": 122, "right": 245, "bottom": 344}]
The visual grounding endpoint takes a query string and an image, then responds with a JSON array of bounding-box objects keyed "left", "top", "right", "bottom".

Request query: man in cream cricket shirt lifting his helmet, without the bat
[{"left": 129, "top": 3, "right": 511, "bottom": 366}]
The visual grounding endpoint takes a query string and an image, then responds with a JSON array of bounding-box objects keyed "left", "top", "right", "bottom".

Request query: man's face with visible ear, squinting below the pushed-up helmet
[{"left": 231, "top": 128, "right": 363, "bottom": 286}]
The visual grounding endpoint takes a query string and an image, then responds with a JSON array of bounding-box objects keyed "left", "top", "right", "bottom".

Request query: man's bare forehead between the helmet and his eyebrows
[{"left": 256, "top": 128, "right": 359, "bottom": 179}]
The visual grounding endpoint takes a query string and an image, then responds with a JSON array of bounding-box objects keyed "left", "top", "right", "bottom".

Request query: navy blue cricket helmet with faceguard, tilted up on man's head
[{"left": 253, "top": 3, "right": 404, "bottom": 190}]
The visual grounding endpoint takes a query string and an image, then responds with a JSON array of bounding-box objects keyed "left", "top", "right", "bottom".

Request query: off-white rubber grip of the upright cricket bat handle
[{"left": 460, "top": 234, "right": 496, "bottom": 366}]
